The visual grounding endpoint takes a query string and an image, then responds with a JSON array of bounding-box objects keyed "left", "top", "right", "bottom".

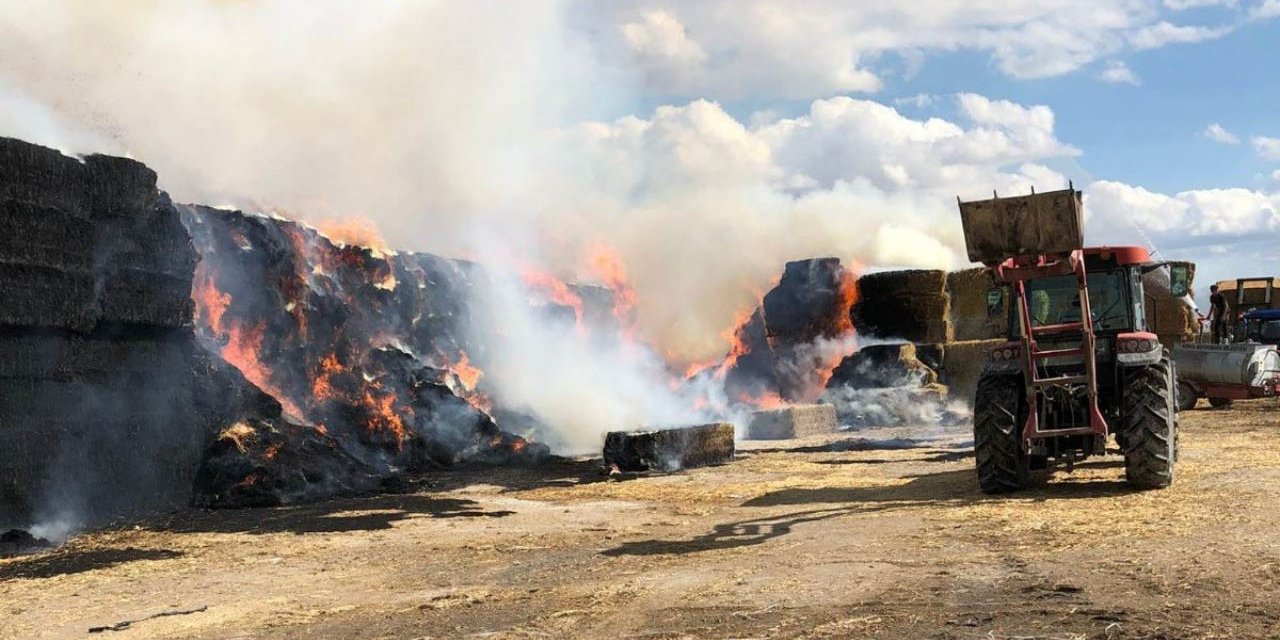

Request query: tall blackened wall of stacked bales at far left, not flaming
[{"left": 0, "top": 138, "right": 204, "bottom": 524}]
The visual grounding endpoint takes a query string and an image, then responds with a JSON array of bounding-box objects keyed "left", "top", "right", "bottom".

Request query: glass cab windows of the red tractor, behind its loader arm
[{"left": 1027, "top": 270, "right": 1132, "bottom": 332}]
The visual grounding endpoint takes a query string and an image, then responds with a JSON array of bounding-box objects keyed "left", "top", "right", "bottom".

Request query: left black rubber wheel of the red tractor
[{"left": 973, "top": 375, "right": 1030, "bottom": 493}]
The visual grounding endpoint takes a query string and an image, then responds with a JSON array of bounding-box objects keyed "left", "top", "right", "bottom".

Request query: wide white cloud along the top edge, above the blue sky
[{"left": 570, "top": 0, "right": 1249, "bottom": 99}]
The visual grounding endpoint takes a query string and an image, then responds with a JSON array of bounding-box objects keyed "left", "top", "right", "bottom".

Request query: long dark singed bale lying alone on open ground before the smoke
[{"left": 604, "top": 422, "right": 733, "bottom": 472}]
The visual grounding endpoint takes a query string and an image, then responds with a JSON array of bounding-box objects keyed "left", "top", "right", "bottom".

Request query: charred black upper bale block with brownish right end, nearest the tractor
[{"left": 851, "top": 270, "right": 951, "bottom": 342}]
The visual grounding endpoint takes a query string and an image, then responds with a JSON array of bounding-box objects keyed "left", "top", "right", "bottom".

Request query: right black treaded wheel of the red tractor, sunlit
[{"left": 1117, "top": 357, "right": 1178, "bottom": 489}]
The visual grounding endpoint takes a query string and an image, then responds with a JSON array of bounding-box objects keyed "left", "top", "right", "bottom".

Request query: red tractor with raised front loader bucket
[{"left": 960, "top": 188, "right": 1187, "bottom": 493}]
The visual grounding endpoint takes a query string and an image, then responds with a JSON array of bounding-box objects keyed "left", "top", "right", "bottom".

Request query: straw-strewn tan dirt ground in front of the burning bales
[{"left": 0, "top": 401, "right": 1280, "bottom": 639}]
